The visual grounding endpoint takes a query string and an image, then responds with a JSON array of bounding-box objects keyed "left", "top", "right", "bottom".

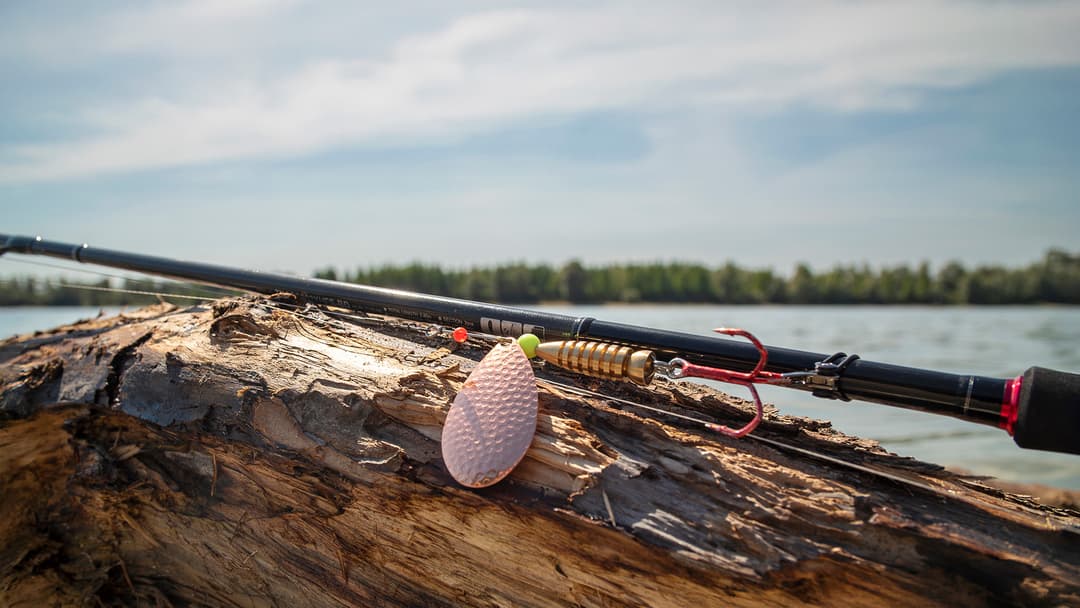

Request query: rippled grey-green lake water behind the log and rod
[{"left": 0, "top": 306, "right": 1080, "bottom": 489}]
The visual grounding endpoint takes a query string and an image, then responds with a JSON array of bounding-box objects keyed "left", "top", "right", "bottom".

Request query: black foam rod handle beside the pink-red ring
[{"left": 1013, "top": 367, "right": 1080, "bottom": 454}]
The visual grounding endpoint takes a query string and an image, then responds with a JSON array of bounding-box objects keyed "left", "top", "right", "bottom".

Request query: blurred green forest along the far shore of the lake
[{"left": 0, "top": 249, "right": 1080, "bottom": 306}]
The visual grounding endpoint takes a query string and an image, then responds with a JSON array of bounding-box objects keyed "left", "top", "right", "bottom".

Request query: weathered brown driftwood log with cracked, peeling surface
[{"left": 0, "top": 297, "right": 1080, "bottom": 608}]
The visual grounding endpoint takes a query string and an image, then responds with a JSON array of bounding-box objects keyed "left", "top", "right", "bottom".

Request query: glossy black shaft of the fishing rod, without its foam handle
[{"left": 0, "top": 234, "right": 1080, "bottom": 452}]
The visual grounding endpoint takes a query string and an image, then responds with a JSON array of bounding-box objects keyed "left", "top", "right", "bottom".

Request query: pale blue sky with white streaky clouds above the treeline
[{"left": 0, "top": 0, "right": 1080, "bottom": 273}]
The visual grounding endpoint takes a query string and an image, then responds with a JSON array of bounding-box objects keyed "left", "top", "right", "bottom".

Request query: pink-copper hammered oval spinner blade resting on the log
[{"left": 442, "top": 343, "right": 537, "bottom": 488}]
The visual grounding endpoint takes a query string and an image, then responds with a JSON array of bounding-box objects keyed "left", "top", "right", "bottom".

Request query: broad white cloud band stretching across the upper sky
[{"left": 0, "top": 0, "right": 1080, "bottom": 181}]
